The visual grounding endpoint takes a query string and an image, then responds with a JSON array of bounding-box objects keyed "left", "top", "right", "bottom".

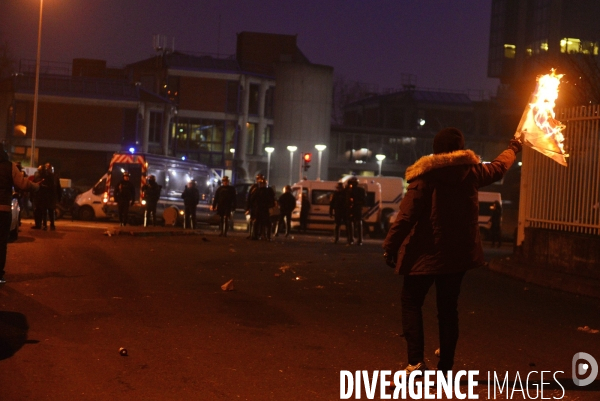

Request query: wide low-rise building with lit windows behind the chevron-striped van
[{"left": 0, "top": 32, "right": 333, "bottom": 190}]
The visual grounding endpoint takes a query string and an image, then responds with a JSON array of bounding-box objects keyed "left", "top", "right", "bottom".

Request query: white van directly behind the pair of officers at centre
[{"left": 292, "top": 180, "right": 381, "bottom": 235}]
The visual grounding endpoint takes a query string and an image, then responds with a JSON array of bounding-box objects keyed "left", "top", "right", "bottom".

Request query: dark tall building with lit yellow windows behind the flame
[{"left": 488, "top": 0, "right": 600, "bottom": 106}]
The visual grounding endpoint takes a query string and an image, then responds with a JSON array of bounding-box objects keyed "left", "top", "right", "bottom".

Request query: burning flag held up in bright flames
[{"left": 515, "top": 70, "right": 569, "bottom": 167}]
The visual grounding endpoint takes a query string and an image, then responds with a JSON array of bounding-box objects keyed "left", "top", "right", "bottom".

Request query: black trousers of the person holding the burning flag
[{"left": 402, "top": 272, "right": 465, "bottom": 371}]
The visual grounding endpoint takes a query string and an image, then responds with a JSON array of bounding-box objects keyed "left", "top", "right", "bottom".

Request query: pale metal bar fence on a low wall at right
[{"left": 517, "top": 105, "right": 600, "bottom": 245}]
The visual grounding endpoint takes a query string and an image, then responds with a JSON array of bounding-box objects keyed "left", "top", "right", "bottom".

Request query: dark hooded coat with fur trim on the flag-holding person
[{"left": 383, "top": 149, "right": 516, "bottom": 275}]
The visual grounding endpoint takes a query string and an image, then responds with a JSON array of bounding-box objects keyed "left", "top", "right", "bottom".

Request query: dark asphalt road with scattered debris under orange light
[{"left": 0, "top": 220, "right": 600, "bottom": 401}]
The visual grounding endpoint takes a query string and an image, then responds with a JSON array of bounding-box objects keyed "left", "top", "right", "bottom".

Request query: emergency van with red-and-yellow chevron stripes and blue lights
[{"left": 76, "top": 152, "right": 218, "bottom": 225}]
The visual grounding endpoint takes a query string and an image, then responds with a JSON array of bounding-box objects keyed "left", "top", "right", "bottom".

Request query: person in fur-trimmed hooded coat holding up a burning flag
[{"left": 383, "top": 128, "right": 522, "bottom": 373}]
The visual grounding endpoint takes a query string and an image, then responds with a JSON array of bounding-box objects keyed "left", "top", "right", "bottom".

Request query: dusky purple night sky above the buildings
[{"left": 0, "top": 0, "right": 498, "bottom": 91}]
